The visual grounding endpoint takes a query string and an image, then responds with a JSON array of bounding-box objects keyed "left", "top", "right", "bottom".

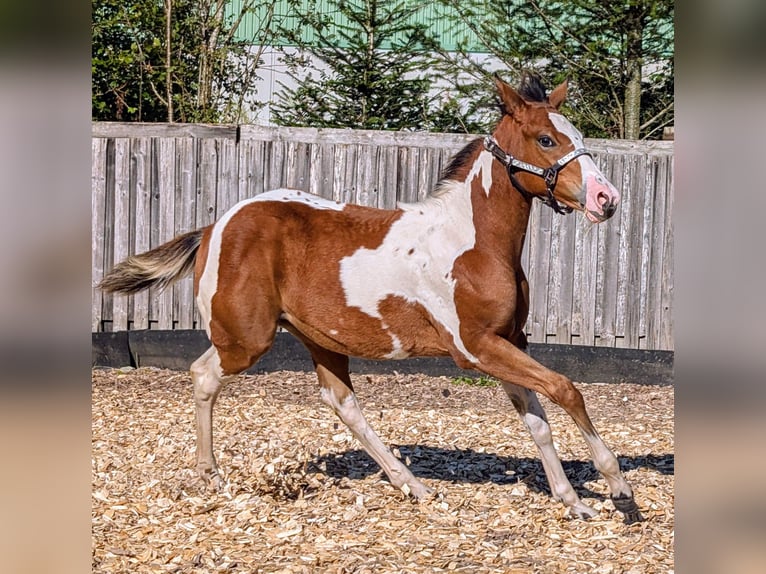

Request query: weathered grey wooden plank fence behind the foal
[{"left": 91, "top": 123, "right": 673, "bottom": 350}]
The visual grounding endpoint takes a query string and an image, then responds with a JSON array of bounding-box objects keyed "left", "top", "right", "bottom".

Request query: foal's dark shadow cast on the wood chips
[{"left": 309, "top": 445, "right": 675, "bottom": 500}]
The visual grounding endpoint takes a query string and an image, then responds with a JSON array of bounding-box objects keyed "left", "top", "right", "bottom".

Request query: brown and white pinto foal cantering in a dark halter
[{"left": 99, "top": 73, "right": 643, "bottom": 523}]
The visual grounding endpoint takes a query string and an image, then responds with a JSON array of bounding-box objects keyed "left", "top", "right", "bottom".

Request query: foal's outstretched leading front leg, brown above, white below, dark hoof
[{"left": 466, "top": 333, "right": 643, "bottom": 523}]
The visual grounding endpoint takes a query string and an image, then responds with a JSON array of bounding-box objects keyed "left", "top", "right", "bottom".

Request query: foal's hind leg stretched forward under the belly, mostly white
[{"left": 304, "top": 340, "right": 433, "bottom": 499}]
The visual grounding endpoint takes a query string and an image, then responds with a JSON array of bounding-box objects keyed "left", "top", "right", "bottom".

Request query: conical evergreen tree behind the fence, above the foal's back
[{"left": 271, "top": 0, "right": 453, "bottom": 130}]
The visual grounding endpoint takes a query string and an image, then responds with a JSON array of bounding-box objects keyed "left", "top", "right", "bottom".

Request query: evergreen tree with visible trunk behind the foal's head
[{"left": 440, "top": 0, "right": 674, "bottom": 139}]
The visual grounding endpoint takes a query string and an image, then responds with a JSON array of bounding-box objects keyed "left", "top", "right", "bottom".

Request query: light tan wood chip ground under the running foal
[{"left": 92, "top": 368, "right": 675, "bottom": 574}]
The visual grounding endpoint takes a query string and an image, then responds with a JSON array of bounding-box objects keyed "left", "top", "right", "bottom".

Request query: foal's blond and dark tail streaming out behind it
[{"left": 98, "top": 229, "right": 204, "bottom": 294}]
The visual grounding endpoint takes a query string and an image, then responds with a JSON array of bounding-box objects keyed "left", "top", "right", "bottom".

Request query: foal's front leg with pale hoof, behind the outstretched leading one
[{"left": 502, "top": 382, "right": 596, "bottom": 519}]
